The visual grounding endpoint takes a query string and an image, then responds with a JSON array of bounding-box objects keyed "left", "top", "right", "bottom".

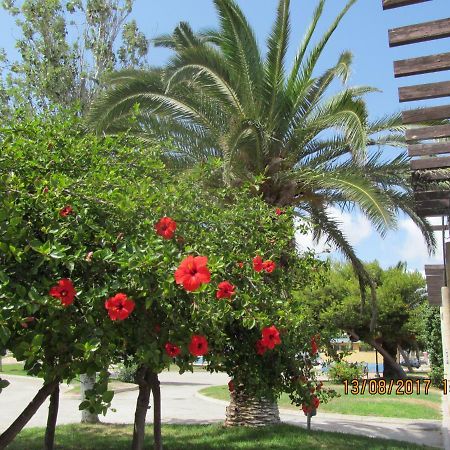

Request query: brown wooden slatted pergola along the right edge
[{"left": 382, "top": 0, "right": 450, "bottom": 305}]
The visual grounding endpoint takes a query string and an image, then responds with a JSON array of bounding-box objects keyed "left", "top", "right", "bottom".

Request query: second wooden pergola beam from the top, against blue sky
[{"left": 389, "top": 18, "right": 450, "bottom": 47}]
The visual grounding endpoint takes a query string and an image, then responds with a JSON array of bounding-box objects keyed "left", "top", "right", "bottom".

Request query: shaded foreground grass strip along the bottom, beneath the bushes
[{"left": 4, "top": 424, "right": 431, "bottom": 450}]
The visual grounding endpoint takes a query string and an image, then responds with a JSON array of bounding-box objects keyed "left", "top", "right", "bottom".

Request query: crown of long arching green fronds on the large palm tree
[{"left": 89, "top": 0, "right": 435, "bottom": 426}]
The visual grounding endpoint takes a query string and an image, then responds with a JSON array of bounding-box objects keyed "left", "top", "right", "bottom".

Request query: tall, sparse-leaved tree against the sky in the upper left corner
[{"left": 0, "top": 0, "right": 148, "bottom": 112}]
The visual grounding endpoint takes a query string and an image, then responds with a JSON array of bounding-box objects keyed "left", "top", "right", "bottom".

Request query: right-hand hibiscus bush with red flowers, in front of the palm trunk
[{"left": 159, "top": 164, "right": 328, "bottom": 422}]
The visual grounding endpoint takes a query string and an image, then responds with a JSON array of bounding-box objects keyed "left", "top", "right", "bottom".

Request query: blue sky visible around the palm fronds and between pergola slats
[{"left": 0, "top": 0, "right": 450, "bottom": 271}]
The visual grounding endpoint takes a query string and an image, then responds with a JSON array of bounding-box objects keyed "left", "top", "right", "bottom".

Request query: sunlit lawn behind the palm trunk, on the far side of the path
[{"left": 200, "top": 383, "right": 442, "bottom": 420}]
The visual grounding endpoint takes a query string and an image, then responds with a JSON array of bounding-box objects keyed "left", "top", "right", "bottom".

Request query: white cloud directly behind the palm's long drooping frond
[{"left": 295, "top": 208, "right": 374, "bottom": 253}]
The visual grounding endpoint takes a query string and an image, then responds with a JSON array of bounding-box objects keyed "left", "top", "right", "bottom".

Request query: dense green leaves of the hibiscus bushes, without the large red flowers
[{"left": 0, "top": 110, "right": 327, "bottom": 418}]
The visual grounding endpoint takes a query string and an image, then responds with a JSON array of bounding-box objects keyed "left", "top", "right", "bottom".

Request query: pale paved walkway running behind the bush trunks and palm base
[{"left": 0, "top": 372, "right": 443, "bottom": 448}]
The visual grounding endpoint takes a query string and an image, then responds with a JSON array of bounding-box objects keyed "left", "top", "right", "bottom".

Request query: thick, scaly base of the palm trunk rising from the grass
[{"left": 225, "top": 385, "right": 280, "bottom": 427}]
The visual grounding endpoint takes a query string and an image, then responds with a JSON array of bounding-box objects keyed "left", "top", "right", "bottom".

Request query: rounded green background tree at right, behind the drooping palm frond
[{"left": 301, "top": 261, "right": 428, "bottom": 378}]
